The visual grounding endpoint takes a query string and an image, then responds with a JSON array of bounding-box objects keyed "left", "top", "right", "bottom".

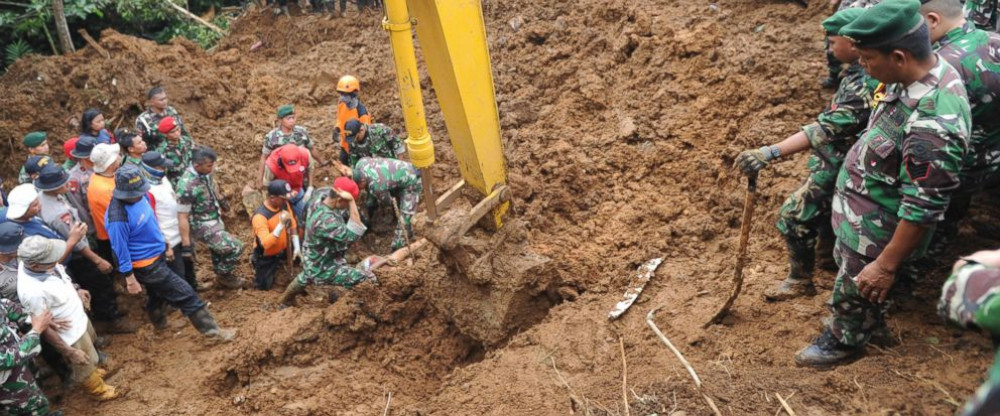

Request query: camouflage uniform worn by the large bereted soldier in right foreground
[{"left": 830, "top": 59, "right": 971, "bottom": 346}]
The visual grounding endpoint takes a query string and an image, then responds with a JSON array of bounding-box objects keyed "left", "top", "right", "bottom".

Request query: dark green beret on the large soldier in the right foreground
[{"left": 840, "top": 0, "right": 924, "bottom": 48}]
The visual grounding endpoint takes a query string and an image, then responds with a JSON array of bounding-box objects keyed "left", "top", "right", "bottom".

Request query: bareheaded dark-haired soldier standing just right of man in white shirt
[{"left": 177, "top": 147, "right": 243, "bottom": 289}]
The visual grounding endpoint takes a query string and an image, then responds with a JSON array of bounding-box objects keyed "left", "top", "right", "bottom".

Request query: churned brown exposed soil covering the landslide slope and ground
[{"left": 0, "top": 0, "right": 997, "bottom": 415}]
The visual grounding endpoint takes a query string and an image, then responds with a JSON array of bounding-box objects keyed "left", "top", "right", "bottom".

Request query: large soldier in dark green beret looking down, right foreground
[{"left": 795, "top": 0, "right": 971, "bottom": 367}]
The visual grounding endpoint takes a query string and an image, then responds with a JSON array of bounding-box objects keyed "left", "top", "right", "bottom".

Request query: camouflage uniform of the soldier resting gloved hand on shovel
[{"left": 777, "top": 63, "right": 878, "bottom": 270}]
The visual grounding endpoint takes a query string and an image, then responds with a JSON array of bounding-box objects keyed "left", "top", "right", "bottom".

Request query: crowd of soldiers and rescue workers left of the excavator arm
[{"left": 0, "top": 75, "right": 422, "bottom": 415}]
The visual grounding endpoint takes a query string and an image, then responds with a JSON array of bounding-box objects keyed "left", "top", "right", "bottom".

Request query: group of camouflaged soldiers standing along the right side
[{"left": 735, "top": 0, "right": 1000, "bottom": 415}]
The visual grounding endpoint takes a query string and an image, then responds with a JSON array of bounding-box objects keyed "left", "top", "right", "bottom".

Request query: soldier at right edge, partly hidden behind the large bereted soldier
[{"left": 920, "top": 0, "right": 1000, "bottom": 259}]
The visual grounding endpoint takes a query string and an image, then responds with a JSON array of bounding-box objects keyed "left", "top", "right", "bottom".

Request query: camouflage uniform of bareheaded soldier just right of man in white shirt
[{"left": 177, "top": 167, "right": 243, "bottom": 276}]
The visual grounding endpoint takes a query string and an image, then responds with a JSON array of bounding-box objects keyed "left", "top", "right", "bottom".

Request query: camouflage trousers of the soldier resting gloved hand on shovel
[{"left": 776, "top": 144, "right": 847, "bottom": 240}]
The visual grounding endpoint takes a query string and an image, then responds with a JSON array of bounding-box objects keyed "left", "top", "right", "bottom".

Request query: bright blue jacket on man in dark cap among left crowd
[{"left": 104, "top": 195, "right": 167, "bottom": 274}]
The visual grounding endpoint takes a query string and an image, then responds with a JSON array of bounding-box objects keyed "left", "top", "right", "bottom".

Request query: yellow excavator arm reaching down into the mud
[{"left": 382, "top": 0, "right": 509, "bottom": 228}]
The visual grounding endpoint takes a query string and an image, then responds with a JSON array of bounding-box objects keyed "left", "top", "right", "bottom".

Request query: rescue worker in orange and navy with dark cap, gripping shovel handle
[{"left": 250, "top": 179, "right": 301, "bottom": 290}]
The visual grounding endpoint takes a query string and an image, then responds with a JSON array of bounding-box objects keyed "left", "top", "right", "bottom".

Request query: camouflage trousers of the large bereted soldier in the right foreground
[{"left": 827, "top": 241, "right": 897, "bottom": 346}]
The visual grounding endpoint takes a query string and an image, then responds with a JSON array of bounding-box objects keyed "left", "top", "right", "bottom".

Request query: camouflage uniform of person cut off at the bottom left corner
[{"left": 0, "top": 299, "right": 49, "bottom": 416}]
